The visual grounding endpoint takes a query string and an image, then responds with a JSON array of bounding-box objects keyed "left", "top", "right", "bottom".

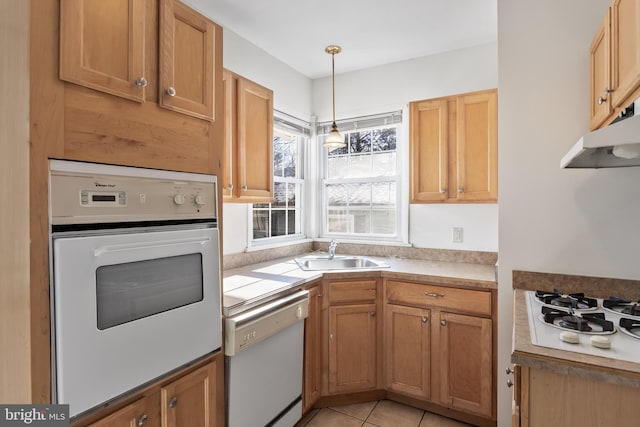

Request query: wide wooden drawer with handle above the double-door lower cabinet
[{"left": 386, "top": 280, "right": 491, "bottom": 316}]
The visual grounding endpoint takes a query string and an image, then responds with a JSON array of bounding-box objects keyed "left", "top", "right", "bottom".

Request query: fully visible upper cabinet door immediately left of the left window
[{"left": 237, "top": 77, "right": 273, "bottom": 202}]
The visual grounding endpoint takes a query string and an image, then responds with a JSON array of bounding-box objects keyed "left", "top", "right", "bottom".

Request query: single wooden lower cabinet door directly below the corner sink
[{"left": 329, "top": 304, "right": 377, "bottom": 393}]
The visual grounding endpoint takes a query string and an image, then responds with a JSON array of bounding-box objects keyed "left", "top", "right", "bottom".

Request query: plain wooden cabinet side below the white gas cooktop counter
[{"left": 513, "top": 366, "right": 640, "bottom": 427}]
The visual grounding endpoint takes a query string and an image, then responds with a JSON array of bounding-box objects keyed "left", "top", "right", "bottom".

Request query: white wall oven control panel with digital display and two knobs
[{"left": 50, "top": 161, "right": 217, "bottom": 224}]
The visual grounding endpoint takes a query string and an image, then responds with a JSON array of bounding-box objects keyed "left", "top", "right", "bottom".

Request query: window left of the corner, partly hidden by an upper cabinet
[{"left": 251, "top": 112, "right": 309, "bottom": 244}]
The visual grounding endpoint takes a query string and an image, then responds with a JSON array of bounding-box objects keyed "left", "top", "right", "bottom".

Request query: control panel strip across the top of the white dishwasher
[{"left": 224, "top": 291, "right": 309, "bottom": 356}]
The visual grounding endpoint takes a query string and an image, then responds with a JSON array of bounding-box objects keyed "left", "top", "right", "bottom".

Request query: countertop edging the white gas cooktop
[{"left": 511, "top": 289, "right": 640, "bottom": 387}]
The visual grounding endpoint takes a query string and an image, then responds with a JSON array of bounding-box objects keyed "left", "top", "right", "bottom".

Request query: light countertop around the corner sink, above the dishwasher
[{"left": 223, "top": 252, "right": 497, "bottom": 316}]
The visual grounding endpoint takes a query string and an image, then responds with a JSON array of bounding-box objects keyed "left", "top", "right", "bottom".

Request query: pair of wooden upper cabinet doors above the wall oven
[{"left": 60, "top": 0, "right": 221, "bottom": 121}]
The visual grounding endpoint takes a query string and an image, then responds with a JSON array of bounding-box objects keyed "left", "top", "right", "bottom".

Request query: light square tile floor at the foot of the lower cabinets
[{"left": 296, "top": 400, "right": 469, "bottom": 427}]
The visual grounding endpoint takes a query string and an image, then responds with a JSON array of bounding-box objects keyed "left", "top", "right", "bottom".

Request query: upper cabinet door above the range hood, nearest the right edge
[{"left": 611, "top": 0, "right": 640, "bottom": 108}]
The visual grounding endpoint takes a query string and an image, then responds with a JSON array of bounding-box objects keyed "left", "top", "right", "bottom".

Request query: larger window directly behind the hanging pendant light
[{"left": 318, "top": 111, "right": 402, "bottom": 240}]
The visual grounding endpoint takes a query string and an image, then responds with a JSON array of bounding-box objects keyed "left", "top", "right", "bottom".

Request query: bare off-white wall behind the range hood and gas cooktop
[{"left": 498, "top": 0, "right": 640, "bottom": 426}]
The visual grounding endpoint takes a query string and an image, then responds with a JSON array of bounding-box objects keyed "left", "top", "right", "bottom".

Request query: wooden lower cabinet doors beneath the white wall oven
[{"left": 83, "top": 354, "right": 225, "bottom": 427}]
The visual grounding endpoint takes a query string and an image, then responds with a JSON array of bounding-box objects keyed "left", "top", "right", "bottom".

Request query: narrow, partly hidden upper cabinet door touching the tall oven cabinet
[{"left": 222, "top": 70, "right": 238, "bottom": 199}]
